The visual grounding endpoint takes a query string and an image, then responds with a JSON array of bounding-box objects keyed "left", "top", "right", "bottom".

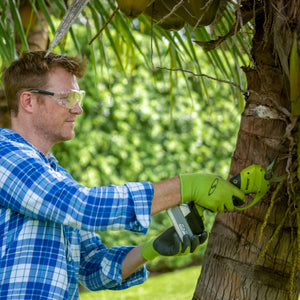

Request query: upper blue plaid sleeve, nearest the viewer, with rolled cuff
[{"left": 0, "top": 138, "right": 153, "bottom": 233}]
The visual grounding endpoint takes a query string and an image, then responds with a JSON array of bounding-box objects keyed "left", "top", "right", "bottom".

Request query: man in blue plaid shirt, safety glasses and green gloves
[{"left": 0, "top": 51, "right": 245, "bottom": 300}]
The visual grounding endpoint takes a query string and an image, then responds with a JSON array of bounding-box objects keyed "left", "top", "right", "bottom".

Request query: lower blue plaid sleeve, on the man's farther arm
[{"left": 79, "top": 232, "right": 148, "bottom": 291}]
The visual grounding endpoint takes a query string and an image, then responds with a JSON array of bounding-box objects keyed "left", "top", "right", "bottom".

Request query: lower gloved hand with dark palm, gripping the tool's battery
[{"left": 141, "top": 226, "right": 206, "bottom": 260}]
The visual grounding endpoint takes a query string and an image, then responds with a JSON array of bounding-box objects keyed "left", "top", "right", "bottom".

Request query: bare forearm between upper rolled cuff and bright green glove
[{"left": 151, "top": 176, "right": 181, "bottom": 215}]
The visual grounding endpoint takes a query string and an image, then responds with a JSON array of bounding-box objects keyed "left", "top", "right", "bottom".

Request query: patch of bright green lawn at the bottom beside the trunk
[{"left": 80, "top": 266, "right": 201, "bottom": 300}]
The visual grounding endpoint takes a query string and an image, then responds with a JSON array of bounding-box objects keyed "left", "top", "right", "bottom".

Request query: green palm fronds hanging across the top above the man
[{"left": 0, "top": 0, "right": 250, "bottom": 108}]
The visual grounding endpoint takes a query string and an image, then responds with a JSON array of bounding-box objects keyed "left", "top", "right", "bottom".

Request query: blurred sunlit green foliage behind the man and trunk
[{"left": 53, "top": 30, "right": 240, "bottom": 270}]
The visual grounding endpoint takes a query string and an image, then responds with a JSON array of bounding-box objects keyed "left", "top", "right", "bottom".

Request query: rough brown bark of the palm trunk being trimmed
[{"left": 193, "top": 1, "right": 300, "bottom": 300}]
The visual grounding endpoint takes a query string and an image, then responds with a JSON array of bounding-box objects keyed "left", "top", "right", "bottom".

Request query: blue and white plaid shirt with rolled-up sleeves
[{"left": 0, "top": 129, "right": 153, "bottom": 300}]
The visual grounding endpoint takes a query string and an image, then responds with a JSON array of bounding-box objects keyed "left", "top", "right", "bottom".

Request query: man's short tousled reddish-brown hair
[{"left": 2, "top": 51, "right": 87, "bottom": 115}]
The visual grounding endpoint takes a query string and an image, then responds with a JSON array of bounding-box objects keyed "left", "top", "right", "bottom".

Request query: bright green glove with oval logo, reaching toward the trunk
[{"left": 180, "top": 173, "right": 245, "bottom": 212}]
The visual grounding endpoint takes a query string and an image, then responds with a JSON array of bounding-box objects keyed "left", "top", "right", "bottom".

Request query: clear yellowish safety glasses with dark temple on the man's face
[{"left": 28, "top": 89, "right": 85, "bottom": 109}]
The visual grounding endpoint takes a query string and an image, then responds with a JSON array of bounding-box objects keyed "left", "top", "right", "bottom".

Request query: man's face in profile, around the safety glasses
[{"left": 33, "top": 67, "right": 83, "bottom": 145}]
